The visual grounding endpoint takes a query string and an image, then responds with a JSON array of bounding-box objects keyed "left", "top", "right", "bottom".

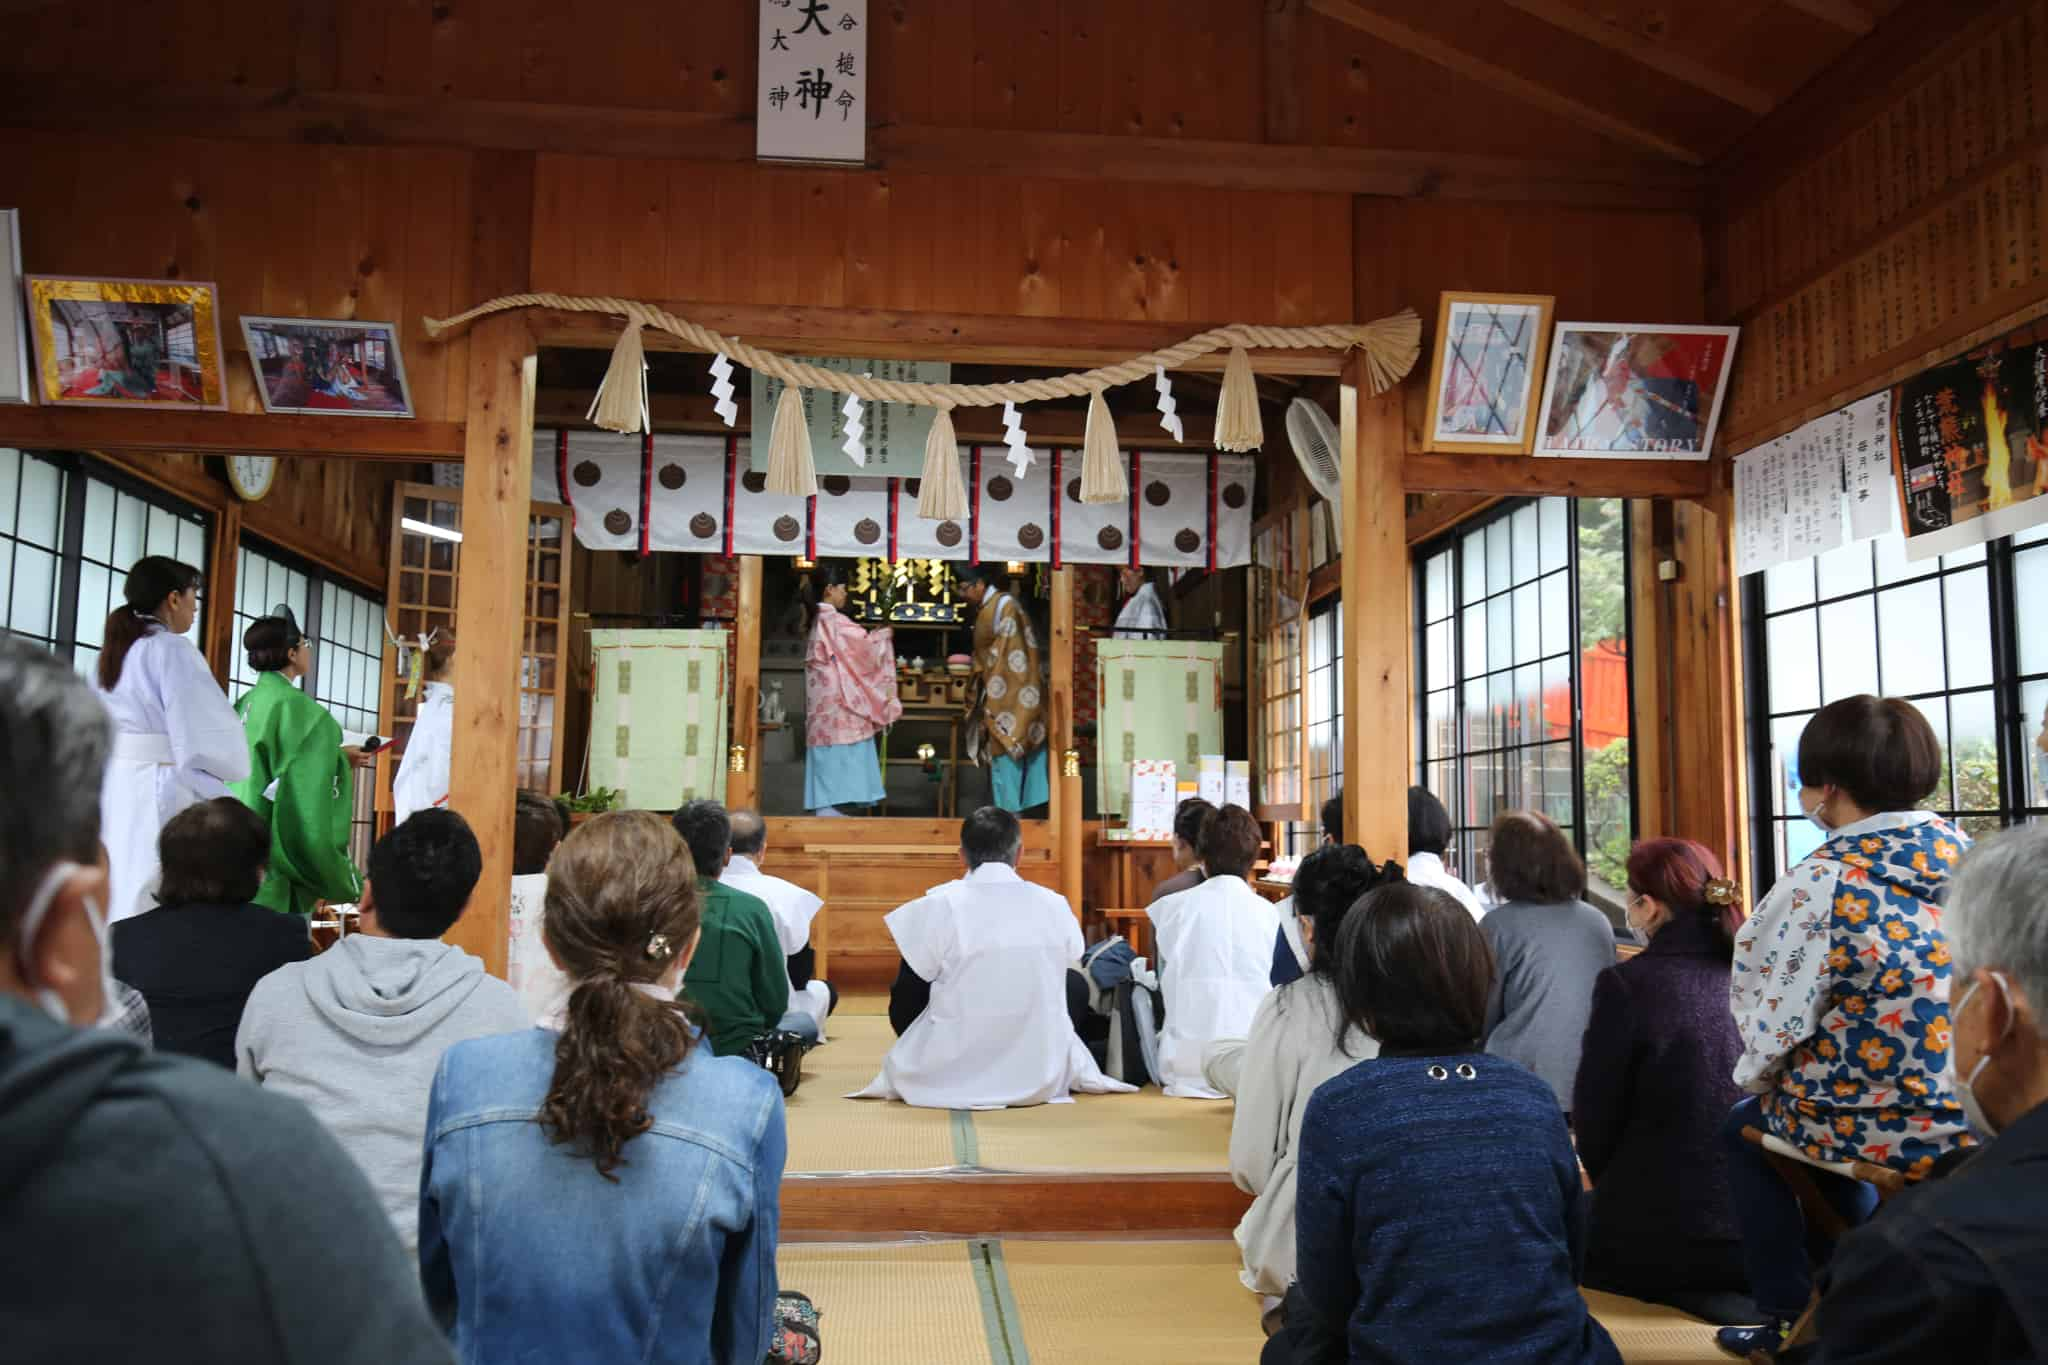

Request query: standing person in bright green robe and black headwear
[{"left": 229, "top": 606, "right": 362, "bottom": 915}]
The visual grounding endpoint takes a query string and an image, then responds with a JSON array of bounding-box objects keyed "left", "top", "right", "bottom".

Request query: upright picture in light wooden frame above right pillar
[{"left": 1423, "top": 289, "right": 1556, "bottom": 454}]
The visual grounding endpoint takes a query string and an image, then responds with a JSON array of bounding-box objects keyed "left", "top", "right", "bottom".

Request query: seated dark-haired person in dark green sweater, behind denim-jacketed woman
[{"left": 672, "top": 800, "right": 788, "bottom": 1056}]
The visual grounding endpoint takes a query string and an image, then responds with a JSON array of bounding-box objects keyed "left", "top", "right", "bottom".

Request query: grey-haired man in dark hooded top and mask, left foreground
[{"left": 0, "top": 639, "right": 453, "bottom": 1365}]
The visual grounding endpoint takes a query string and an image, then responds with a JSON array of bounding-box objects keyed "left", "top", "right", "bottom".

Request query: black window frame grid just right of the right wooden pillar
[{"left": 1409, "top": 495, "right": 1642, "bottom": 896}]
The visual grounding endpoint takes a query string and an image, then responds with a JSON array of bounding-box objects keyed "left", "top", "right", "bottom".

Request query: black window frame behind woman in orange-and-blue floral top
[{"left": 1741, "top": 530, "right": 2048, "bottom": 896}]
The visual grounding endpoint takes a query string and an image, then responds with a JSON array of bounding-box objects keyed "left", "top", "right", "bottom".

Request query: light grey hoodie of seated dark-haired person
[{"left": 236, "top": 933, "right": 528, "bottom": 1252}]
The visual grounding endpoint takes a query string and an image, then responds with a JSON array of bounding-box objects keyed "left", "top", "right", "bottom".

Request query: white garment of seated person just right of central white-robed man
[{"left": 1145, "top": 876, "right": 1280, "bottom": 1099}]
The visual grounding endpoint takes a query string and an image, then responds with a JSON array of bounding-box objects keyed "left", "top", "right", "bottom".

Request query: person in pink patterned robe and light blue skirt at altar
[{"left": 803, "top": 567, "right": 903, "bottom": 814}]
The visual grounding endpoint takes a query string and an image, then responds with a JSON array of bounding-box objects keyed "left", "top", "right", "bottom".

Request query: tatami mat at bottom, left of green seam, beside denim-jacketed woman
[{"left": 776, "top": 1242, "right": 1012, "bottom": 1365}]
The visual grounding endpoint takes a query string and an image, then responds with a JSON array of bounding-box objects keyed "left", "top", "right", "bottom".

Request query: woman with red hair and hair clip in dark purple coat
[{"left": 1571, "top": 839, "right": 1755, "bottom": 1324}]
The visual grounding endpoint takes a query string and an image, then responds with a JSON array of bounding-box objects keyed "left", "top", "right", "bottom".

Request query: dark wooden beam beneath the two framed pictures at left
[{"left": 0, "top": 403, "right": 463, "bottom": 463}]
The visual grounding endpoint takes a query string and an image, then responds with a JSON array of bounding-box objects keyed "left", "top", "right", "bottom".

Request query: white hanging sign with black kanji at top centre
[{"left": 754, "top": 0, "right": 868, "bottom": 164}]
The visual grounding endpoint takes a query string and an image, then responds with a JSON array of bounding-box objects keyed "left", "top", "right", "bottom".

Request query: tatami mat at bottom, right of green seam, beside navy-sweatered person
[{"left": 1003, "top": 1238, "right": 1266, "bottom": 1365}]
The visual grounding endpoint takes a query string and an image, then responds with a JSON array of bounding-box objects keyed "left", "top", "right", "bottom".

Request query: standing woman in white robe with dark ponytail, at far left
[{"left": 98, "top": 555, "right": 250, "bottom": 923}]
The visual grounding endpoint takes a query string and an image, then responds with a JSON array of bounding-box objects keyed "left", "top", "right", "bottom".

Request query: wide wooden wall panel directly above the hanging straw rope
[{"left": 532, "top": 156, "right": 1352, "bottom": 323}]
